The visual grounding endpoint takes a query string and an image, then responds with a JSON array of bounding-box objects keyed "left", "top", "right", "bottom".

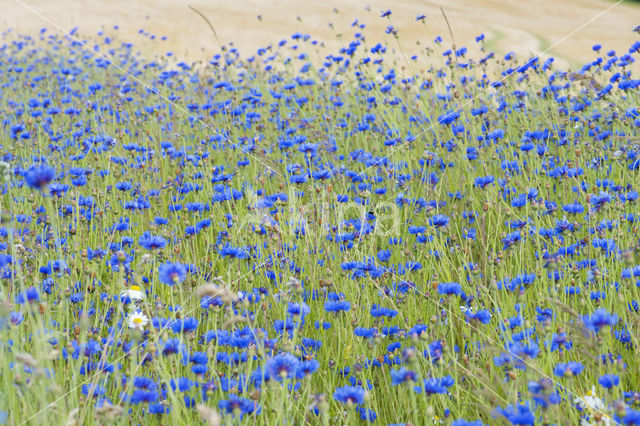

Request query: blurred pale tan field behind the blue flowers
[{"left": 0, "top": 0, "right": 640, "bottom": 69}]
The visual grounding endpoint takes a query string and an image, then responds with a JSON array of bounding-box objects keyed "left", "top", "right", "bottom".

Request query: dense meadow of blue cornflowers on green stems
[{"left": 0, "top": 11, "right": 640, "bottom": 426}]
